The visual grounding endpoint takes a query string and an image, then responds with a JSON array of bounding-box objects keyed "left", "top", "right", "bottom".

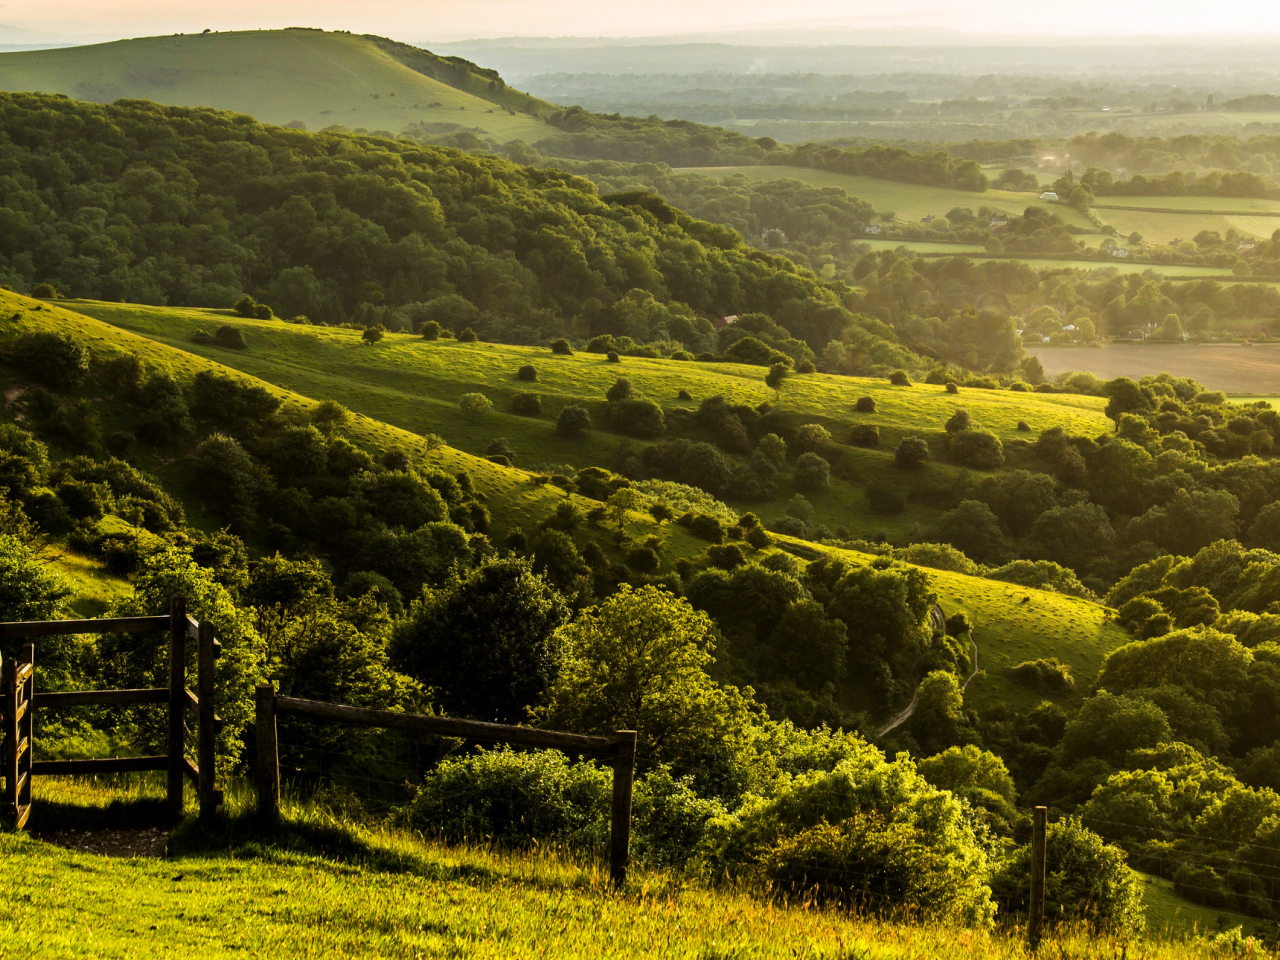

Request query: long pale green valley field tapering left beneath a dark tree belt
[{"left": 680, "top": 166, "right": 1093, "bottom": 230}]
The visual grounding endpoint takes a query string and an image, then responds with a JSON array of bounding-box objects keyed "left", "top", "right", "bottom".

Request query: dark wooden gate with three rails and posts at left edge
[{"left": 0, "top": 596, "right": 221, "bottom": 829}]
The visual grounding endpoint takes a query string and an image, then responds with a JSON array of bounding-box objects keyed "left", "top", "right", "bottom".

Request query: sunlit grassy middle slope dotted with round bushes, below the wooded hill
[{"left": 68, "top": 301, "right": 1108, "bottom": 545}]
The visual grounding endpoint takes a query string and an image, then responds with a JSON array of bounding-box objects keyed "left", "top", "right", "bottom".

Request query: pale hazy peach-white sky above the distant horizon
[{"left": 10, "top": 0, "right": 1280, "bottom": 40}]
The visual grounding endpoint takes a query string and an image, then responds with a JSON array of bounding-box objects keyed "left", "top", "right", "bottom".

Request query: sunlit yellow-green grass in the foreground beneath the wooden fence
[{"left": 0, "top": 777, "right": 1265, "bottom": 960}]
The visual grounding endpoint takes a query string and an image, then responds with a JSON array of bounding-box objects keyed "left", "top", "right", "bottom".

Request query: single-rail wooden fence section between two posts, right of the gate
[{"left": 255, "top": 685, "right": 636, "bottom": 883}]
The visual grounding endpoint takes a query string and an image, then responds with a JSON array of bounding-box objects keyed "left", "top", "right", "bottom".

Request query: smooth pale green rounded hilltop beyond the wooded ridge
[{"left": 0, "top": 29, "right": 554, "bottom": 141}]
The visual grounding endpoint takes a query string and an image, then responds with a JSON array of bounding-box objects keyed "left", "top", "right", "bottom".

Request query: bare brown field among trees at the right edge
[{"left": 1027, "top": 343, "right": 1280, "bottom": 394}]
